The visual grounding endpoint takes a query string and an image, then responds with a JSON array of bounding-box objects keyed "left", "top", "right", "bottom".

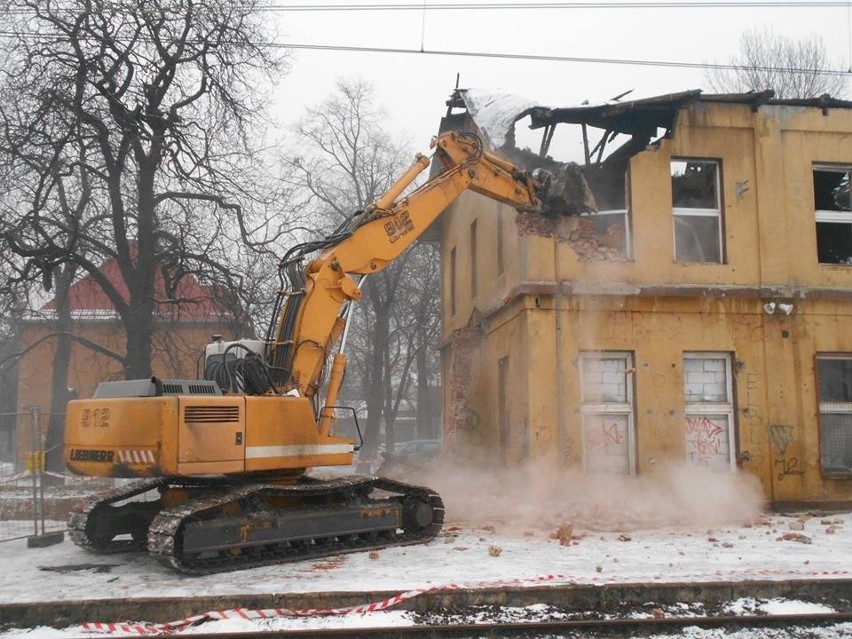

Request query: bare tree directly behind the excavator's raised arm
[{"left": 290, "top": 80, "right": 437, "bottom": 457}]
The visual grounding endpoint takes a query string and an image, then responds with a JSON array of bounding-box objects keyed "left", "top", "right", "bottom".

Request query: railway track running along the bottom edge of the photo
[{"left": 61, "top": 612, "right": 852, "bottom": 639}]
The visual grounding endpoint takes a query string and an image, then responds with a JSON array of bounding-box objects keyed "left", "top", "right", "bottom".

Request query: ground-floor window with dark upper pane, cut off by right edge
[{"left": 816, "top": 355, "right": 852, "bottom": 474}]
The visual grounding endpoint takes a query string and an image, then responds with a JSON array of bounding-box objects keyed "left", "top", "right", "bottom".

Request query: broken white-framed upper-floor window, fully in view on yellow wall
[{"left": 671, "top": 160, "right": 723, "bottom": 264}]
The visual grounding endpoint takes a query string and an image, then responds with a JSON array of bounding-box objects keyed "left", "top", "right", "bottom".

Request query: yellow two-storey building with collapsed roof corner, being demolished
[{"left": 439, "top": 90, "right": 852, "bottom": 508}]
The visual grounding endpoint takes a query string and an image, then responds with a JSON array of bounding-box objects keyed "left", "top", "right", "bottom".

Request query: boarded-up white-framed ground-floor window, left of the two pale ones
[{"left": 580, "top": 353, "right": 635, "bottom": 475}]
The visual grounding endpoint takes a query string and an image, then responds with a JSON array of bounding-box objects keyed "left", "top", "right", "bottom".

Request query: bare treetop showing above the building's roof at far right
[{"left": 705, "top": 28, "right": 847, "bottom": 98}]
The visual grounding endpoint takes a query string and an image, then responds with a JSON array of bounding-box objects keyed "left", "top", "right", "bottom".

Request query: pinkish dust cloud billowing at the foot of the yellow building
[{"left": 390, "top": 459, "right": 764, "bottom": 534}]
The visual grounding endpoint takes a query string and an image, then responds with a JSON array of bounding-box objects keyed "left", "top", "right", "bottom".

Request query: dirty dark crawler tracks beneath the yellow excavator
[{"left": 72, "top": 476, "right": 444, "bottom": 575}]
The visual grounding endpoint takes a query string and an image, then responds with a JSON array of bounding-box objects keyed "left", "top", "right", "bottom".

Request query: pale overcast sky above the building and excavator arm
[{"left": 269, "top": 0, "right": 852, "bottom": 151}]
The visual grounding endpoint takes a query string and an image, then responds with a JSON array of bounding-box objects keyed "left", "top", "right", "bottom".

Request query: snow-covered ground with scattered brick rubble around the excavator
[{"left": 0, "top": 464, "right": 852, "bottom": 639}]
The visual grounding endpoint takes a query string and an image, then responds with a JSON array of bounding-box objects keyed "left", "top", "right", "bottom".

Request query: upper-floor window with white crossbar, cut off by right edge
[{"left": 814, "top": 166, "right": 852, "bottom": 265}]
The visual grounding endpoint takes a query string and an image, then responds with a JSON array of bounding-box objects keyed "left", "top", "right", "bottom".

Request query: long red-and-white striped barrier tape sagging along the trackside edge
[{"left": 80, "top": 575, "right": 566, "bottom": 635}]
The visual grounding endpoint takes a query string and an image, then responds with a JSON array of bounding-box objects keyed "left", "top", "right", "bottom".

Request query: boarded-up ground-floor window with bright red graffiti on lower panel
[{"left": 683, "top": 353, "right": 735, "bottom": 471}]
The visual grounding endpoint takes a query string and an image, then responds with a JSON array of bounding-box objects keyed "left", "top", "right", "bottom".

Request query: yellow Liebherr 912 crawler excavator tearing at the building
[{"left": 64, "top": 131, "right": 593, "bottom": 574}]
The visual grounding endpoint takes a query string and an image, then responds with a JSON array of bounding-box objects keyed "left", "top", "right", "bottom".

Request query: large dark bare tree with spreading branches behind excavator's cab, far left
[{"left": 0, "top": 0, "right": 286, "bottom": 378}]
